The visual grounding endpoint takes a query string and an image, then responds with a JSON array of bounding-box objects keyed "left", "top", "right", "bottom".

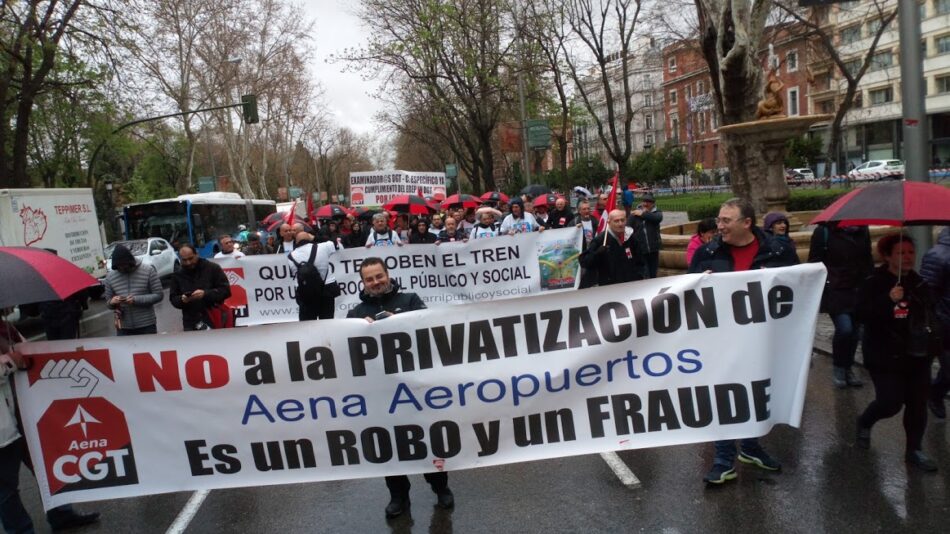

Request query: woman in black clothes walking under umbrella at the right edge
[{"left": 855, "top": 234, "right": 941, "bottom": 471}]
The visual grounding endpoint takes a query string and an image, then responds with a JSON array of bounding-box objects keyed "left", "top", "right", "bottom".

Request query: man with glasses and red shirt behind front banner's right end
[{"left": 689, "top": 198, "right": 798, "bottom": 484}]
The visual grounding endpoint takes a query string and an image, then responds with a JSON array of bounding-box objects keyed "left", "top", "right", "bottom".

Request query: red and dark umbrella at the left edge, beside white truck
[{"left": 0, "top": 247, "right": 99, "bottom": 308}]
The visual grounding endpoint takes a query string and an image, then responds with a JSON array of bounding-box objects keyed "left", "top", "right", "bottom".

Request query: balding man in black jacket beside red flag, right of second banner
[{"left": 581, "top": 210, "right": 646, "bottom": 286}]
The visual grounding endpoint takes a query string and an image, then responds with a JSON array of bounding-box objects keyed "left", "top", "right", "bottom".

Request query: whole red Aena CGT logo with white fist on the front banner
[{"left": 28, "top": 350, "right": 138, "bottom": 495}]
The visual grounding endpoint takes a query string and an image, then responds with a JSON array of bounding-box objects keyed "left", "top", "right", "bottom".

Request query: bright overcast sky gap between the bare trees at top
[{"left": 302, "top": 0, "right": 380, "bottom": 133}]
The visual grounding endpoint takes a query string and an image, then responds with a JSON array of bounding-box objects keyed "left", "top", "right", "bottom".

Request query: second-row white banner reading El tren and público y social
[{"left": 214, "top": 228, "right": 581, "bottom": 326}]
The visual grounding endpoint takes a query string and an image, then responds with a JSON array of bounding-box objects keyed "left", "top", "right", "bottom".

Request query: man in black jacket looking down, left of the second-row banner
[{"left": 169, "top": 244, "right": 231, "bottom": 332}]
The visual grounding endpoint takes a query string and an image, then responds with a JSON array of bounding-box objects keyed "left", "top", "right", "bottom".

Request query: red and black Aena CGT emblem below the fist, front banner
[{"left": 37, "top": 397, "right": 139, "bottom": 495}]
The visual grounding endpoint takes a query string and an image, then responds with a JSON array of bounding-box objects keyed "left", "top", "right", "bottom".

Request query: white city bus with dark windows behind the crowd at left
[{"left": 123, "top": 191, "right": 277, "bottom": 258}]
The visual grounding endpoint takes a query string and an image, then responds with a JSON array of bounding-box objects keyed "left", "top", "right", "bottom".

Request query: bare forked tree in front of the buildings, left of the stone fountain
[{"left": 565, "top": 0, "right": 643, "bottom": 180}]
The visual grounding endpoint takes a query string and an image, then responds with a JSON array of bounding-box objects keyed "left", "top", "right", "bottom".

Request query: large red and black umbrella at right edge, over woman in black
[{"left": 811, "top": 181, "right": 950, "bottom": 226}]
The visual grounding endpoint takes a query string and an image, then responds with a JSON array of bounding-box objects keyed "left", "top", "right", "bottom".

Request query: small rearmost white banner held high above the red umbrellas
[{"left": 350, "top": 171, "right": 446, "bottom": 207}]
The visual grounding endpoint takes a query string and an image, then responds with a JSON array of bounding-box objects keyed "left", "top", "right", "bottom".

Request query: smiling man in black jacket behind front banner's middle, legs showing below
[{"left": 346, "top": 257, "right": 455, "bottom": 518}]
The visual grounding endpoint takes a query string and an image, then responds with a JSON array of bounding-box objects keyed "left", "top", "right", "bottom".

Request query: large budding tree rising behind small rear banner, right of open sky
[{"left": 343, "top": 0, "right": 513, "bottom": 193}]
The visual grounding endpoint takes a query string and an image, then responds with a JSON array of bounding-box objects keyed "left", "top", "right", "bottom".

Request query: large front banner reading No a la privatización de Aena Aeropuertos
[{"left": 17, "top": 264, "right": 825, "bottom": 508}]
